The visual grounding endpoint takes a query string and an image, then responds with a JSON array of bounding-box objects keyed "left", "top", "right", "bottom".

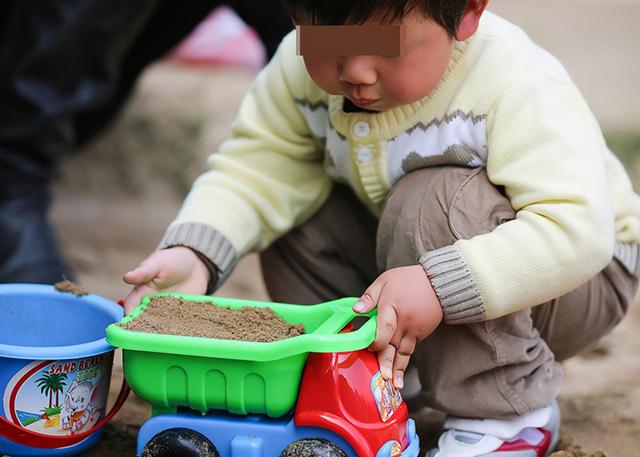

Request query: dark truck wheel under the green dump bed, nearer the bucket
[{"left": 142, "top": 428, "right": 220, "bottom": 457}]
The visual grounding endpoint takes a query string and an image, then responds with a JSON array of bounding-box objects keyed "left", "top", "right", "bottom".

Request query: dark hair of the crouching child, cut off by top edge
[{"left": 284, "top": 0, "right": 469, "bottom": 36}]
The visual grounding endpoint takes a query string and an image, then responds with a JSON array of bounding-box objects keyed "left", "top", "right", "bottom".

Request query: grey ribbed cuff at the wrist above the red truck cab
[{"left": 420, "top": 246, "right": 486, "bottom": 324}]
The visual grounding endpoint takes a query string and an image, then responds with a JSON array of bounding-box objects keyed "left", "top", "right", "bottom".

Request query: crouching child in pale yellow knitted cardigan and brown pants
[{"left": 124, "top": 0, "right": 640, "bottom": 456}]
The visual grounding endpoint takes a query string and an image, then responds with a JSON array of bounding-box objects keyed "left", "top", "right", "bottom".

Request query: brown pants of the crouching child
[{"left": 261, "top": 167, "right": 638, "bottom": 417}]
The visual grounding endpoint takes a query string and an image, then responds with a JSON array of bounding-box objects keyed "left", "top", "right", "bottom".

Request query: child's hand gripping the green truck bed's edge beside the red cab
[{"left": 353, "top": 265, "right": 443, "bottom": 389}]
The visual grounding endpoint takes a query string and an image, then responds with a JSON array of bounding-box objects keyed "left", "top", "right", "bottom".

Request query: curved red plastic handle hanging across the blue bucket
[{"left": 0, "top": 380, "right": 131, "bottom": 449}]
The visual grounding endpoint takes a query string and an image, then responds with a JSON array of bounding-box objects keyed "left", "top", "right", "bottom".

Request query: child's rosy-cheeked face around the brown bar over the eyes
[{"left": 301, "top": 11, "right": 453, "bottom": 111}]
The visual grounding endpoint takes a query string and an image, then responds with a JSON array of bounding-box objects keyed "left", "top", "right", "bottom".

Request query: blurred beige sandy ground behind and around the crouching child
[{"left": 40, "top": 0, "right": 640, "bottom": 457}]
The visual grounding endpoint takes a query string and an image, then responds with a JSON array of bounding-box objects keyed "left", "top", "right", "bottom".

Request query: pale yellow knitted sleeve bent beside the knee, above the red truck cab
[{"left": 421, "top": 71, "right": 615, "bottom": 323}]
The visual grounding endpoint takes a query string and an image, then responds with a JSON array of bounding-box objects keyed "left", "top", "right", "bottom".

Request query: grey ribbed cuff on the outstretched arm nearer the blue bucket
[{"left": 157, "top": 222, "right": 238, "bottom": 293}]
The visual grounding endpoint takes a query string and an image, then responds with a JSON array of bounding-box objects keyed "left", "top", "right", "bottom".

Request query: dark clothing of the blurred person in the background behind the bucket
[{"left": 0, "top": 0, "right": 292, "bottom": 283}]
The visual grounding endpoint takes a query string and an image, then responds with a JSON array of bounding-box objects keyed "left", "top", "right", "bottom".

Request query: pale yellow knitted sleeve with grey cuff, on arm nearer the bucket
[{"left": 160, "top": 35, "right": 331, "bottom": 282}]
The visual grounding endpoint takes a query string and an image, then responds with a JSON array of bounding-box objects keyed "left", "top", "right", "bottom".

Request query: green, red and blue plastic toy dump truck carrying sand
[{"left": 107, "top": 294, "right": 419, "bottom": 457}]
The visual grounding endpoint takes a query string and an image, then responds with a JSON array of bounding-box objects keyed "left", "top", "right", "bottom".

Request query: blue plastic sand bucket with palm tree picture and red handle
[{"left": 0, "top": 284, "right": 128, "bottom": 457}]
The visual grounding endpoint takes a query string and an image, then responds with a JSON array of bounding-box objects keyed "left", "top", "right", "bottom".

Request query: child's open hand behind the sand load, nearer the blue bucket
[{"left": 122, "top": 246, "right": 211, "bottom": 314}]
